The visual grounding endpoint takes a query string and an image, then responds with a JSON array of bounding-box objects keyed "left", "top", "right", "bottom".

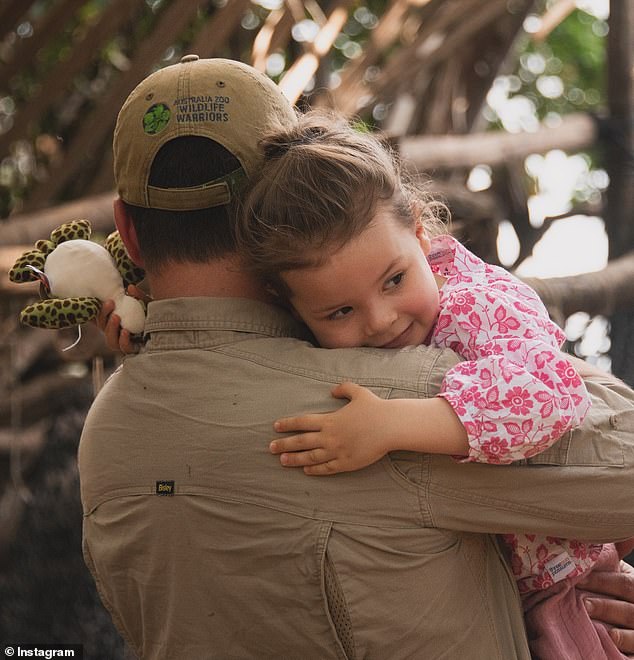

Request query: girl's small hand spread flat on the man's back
[{"left": 270, "top": 383, "right": 391, "bottom": 475}]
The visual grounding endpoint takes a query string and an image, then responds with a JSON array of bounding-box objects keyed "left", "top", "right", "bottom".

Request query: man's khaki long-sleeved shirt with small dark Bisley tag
[{"left": 79, "top": 298, "right": 634, "bottom": 660}]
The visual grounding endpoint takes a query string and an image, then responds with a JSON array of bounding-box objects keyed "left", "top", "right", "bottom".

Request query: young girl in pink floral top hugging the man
[{"left": 238, "top": 113, "right": 622, "bottom": 659}]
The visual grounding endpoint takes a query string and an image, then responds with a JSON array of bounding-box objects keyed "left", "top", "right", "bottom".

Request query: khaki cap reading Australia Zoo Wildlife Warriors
[{"left": 113, "top": 55, "right": 296, "bottom": 211}]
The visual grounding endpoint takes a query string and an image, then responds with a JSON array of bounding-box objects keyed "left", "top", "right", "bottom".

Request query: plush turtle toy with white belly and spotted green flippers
[{"left": 9, "top": 220, "right": 145, "bottom": 334}]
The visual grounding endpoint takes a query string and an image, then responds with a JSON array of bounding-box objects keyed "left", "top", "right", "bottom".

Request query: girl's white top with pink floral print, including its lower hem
[{"left": 428, "top": 236, "right": 602, "bottom": 592}]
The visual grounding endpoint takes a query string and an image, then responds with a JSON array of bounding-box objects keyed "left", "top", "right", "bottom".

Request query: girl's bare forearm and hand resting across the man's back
[{"left": 270, "top": 383, "right": 469, "bottom": 475}]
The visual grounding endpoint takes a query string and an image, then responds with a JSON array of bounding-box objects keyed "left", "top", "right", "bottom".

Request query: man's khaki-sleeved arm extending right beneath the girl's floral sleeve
[{"left": 392, "top": 379, "right": 634, "bottom": 542}]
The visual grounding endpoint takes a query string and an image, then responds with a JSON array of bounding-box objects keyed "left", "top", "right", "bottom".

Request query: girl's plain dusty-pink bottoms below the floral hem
[{"left": 523, "top": 544, "right": 626, "bottom": 660}]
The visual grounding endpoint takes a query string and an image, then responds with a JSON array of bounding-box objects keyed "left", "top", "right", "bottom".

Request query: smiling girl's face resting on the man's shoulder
[{"left": 282, "top": 205, "right": 444, "bottom": 348}]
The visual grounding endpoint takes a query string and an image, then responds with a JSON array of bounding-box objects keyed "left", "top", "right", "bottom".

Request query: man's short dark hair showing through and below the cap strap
[{"left": 125, "top": 136, "right": 240, "bottom": 270}]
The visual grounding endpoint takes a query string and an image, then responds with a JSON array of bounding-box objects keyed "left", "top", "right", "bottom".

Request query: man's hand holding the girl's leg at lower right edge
[{"left": 577, "top": 539, "right": 634, "bottom": 658}]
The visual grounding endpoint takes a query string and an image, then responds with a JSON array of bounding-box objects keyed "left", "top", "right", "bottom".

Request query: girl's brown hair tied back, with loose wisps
[{"left": 236, "top": 111, "right": 447, "bottom": 298}]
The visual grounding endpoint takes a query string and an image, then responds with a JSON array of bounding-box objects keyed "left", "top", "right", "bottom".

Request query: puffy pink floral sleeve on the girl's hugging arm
[{"left": 434, "top": 281, "right": 590, "bottom": 464}]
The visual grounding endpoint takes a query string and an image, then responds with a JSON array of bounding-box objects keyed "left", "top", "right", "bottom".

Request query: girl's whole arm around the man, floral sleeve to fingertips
[{"left": 271, "top": 276, "right": 590, "bottom": 474}]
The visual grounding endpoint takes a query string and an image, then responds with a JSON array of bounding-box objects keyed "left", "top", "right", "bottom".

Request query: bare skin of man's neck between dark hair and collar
[{"left": 147, "top": 257, "right": 269, "bottom": 302}]
